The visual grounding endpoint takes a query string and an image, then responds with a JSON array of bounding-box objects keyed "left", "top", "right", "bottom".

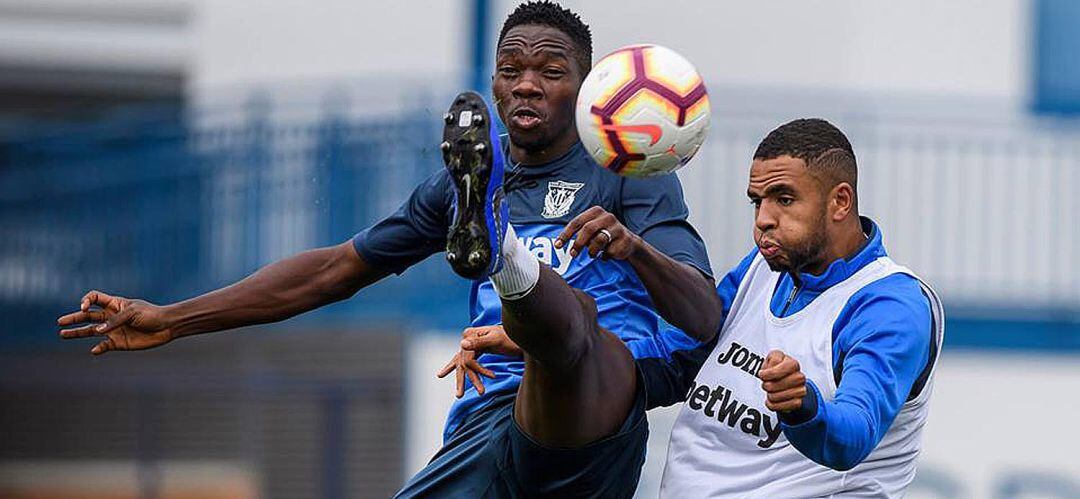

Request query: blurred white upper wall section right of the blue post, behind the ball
[{"left": 535, "top": 0, "right": 1029, "bottom": 98}]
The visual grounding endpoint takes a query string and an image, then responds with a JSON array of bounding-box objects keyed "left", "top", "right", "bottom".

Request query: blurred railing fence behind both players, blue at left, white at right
[{"left": 0, "top": 96, "right": 1080, "bottom": 342}]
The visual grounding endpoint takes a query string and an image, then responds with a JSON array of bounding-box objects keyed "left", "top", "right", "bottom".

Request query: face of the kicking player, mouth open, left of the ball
[{"left": 491, "top": 25, "right": 584, "bottom": 161}]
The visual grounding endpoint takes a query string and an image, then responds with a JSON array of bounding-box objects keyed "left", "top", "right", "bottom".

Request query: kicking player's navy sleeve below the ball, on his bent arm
[{"left": 620, "top": 175, "right": 713, "bottom": 275}]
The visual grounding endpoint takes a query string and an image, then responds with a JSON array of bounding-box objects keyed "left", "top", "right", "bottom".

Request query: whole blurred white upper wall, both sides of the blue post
[{"left": 185, "top": 0, "right": 1029, "bottom": 98}]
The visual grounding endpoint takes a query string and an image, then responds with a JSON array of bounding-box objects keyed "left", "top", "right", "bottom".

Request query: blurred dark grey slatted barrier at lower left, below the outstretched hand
[{"left": 0, "top": 327, "right": 406, "bottom": 499}]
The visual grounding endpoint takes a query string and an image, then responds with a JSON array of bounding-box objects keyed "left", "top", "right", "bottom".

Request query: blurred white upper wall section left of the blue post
[{"left": 192, "top": 0, "right": 469, "bottom": 93}]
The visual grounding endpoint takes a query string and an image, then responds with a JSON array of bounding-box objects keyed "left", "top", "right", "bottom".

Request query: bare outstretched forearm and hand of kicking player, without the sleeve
[{"left": 57, "top": 241, "right": 388, "bottom": 354}]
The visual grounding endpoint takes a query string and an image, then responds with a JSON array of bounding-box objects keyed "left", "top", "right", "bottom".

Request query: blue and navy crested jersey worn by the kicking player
[{"left": 353, "top": 143, "right": 711, "bottom": 439}]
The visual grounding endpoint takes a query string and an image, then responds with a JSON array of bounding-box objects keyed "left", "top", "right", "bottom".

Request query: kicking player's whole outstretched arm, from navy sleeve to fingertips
[{"left": 57, "top": 170, "right": 450, "bottom": 354}]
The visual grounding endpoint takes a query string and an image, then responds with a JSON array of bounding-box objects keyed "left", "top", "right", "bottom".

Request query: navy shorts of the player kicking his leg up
[{"left": 395, "top": 375, "right": 649, "bottom": 498}]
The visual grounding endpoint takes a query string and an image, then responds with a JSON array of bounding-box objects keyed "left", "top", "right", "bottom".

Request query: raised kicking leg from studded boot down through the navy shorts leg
[{"left": 442, "top": 93, "right": 648, "bottom": 497}]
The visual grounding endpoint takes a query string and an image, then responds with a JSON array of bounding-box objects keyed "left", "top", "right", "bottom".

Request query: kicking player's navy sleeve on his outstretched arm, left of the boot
[{"left": 352, "top": 170, "right": 454, "bottom": 273}]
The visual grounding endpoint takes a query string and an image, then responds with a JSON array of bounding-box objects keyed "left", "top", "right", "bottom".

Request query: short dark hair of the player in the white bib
[{"left": 754, "top": 118, "right": 859, "bottom": 194}]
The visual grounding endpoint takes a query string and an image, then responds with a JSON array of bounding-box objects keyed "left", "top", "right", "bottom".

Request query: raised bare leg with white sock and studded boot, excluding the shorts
[{"left": 441, "top": 92, "right": 637, "bottom": 447}]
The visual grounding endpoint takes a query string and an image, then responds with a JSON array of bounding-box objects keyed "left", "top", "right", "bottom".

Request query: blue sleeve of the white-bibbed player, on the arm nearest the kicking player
[{"left": 629, "top": 248, "right": 757, "bottom": 409}]
